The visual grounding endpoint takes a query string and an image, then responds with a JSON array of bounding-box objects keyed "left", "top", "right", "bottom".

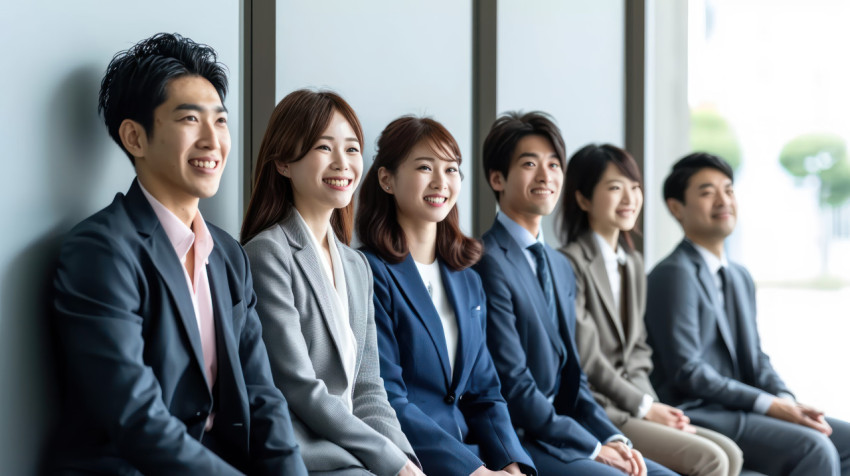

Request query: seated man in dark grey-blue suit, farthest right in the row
[{"left": 645, "top": 153, "right": 850, "bottom": 475}]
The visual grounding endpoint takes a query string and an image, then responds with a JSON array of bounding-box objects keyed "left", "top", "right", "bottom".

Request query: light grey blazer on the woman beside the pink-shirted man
[{"left": 245, "top": 212, "right": 417, "bottom": 475}]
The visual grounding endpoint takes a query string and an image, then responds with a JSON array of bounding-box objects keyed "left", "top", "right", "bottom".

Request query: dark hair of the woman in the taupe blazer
[{"left": 558, "top": 144, "right": 642, "bottom": 250}]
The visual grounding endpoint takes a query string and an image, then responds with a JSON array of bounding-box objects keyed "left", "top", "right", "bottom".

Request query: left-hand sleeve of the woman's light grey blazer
[{"left": 245, "top": 236, "right": 407, "bottom": 475}]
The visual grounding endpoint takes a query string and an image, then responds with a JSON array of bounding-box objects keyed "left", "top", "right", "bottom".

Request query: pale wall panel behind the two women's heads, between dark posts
[{"left": 276, "top": 0, "right": 474, "bottom": 233}]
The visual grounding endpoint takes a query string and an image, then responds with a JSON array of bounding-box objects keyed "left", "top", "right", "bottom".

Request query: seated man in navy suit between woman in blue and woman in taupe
[{"left": 475, "top": 112, "right": 673, "bottom": 476}]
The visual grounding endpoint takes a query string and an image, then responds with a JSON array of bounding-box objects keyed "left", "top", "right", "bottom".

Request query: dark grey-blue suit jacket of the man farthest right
[{"left": 645, "top": 240, "right": 791, "bottom": 411}]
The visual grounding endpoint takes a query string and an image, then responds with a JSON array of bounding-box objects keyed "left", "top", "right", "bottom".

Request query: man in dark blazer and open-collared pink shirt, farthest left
[{"left": 51, "top": 34, "right": 306, "bottom": 475}]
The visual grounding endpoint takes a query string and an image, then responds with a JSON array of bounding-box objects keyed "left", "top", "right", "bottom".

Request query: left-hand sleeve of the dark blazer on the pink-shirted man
[{"left": 54, "top": 230, "right": 241, "bottom": 475}]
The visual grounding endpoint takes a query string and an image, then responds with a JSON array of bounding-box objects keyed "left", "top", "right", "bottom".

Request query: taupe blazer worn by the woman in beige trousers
[{"left": 561, "top": 232, "right": 657, "bottom": 426}]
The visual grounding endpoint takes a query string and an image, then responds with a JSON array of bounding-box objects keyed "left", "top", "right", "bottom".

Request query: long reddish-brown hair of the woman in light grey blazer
[{"left": 240, "top": 89, "right": 363, "bottom": 245}]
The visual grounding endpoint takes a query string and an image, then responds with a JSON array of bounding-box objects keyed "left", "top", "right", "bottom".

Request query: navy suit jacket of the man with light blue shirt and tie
[{"left": 475, "top": 221, "right": 620, "bottom": 462}]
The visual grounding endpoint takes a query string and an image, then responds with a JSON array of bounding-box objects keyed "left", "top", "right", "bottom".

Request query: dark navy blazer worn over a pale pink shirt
[{"left": 53, "top": 180, "right": 307, "bottom": 475}]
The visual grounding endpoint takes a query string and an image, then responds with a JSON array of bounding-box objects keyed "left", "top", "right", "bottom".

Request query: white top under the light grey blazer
[{"left": 293, "top": 209, "right": 357, "bottom": 411}]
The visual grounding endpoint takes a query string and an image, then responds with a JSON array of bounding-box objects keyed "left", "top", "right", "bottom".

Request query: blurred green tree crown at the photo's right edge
[{"left": 779, "top": 132, "right": 850, "bottom": 207}]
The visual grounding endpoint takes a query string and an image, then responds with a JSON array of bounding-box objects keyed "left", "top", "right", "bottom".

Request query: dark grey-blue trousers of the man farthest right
[{"left": 688, "top": 409, "right": 850, "bottom": 476}]
